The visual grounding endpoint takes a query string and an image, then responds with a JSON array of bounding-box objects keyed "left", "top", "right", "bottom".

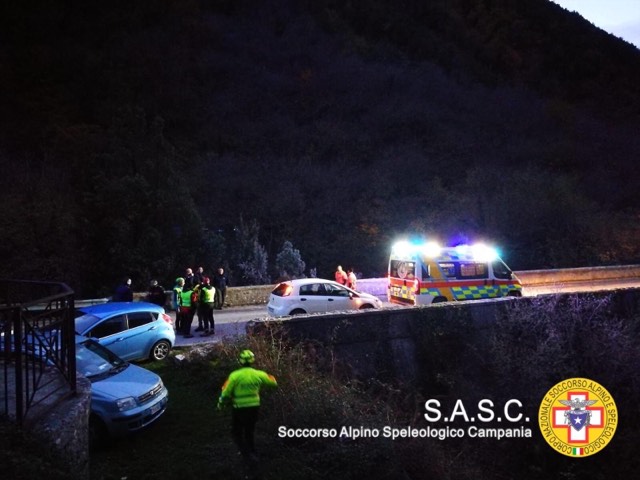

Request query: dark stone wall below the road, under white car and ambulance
[{"left": 247, "top": 289, "right": 640, "bottom": 383}]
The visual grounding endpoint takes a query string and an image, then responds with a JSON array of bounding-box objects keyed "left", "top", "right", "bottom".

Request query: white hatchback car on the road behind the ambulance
[{"left": 267, "top": 278, "right": 382, "bottom": 317}]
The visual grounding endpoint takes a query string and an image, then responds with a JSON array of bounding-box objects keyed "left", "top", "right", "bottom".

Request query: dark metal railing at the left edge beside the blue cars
[{"left": 0, "top": 280, "right": 76, "bottom": 424}]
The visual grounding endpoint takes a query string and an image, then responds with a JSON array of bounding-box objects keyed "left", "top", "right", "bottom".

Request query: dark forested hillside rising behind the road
[{"left": 0, "top": 0, "right": 640, "bottom": 295}]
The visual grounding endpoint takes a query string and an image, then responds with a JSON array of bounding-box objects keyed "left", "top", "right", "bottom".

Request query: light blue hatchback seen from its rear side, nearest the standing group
[{"left": 75, "top": 302, "right": 176, "bottom": 361}]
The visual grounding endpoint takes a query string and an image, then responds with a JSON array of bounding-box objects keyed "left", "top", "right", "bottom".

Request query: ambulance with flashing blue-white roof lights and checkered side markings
[{"left": 387, "top": 241, "right": 522, "bottom": 305}]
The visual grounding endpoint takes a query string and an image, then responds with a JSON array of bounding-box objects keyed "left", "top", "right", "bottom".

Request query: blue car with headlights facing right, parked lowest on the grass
[{"left": 76, "top": 335, "right": 169, "bottom": 445}]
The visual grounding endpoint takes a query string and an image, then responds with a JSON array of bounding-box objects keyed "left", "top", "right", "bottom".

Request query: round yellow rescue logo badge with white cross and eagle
[{"left": 538, "top": 378, "right": 618, "bottom": 457}]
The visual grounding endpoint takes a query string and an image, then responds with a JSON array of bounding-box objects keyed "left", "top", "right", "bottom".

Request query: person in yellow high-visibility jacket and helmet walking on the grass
[{"left": 218, "top": 350, "right": 278, "bottom": 460}]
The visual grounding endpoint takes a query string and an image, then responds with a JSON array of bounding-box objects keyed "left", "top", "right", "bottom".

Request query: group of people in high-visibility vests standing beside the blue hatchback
[{"left": 172, "top": 267, "right": 229, "bottom": 338}]
